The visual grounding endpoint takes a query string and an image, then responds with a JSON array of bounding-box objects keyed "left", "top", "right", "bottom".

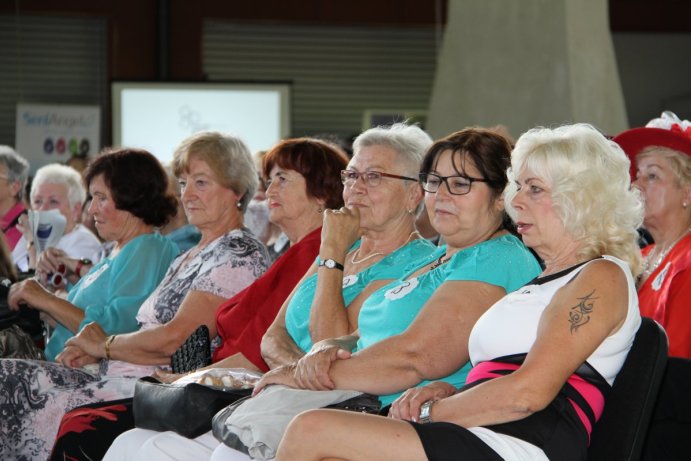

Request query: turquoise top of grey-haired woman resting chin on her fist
[{"left": 286, "top": 239, "right": 436, "bottom": 352}]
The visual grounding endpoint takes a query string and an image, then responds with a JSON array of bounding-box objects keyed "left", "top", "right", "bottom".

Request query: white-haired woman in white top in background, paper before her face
[{"left": 12, "top": 163, "right": 101, "bottom": 274}]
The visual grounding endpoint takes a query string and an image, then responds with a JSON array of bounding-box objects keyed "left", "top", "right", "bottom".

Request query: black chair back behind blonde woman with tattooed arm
[{"left": 588, "top": 317, "right": 667, "bottom": 461}]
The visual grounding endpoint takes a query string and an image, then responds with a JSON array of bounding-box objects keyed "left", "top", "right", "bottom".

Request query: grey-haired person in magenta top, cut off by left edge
[{"left": 0, "top": 146, "right": 29, "bottom": 251}]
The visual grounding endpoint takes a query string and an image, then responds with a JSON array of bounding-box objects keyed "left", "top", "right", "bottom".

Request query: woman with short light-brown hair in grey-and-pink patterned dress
[{"left": 0, "top": 132, "right": 269, "bottom": 459}]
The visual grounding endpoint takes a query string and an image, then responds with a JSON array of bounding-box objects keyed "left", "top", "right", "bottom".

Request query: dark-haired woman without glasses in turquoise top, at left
[{"left": 8, "top": 149, "right": 178, "bottom": 360}]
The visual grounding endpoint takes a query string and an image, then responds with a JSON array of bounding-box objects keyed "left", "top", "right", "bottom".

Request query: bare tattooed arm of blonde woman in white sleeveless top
[{"left": 432, "top": 261, "right": 628, "bottom": 427}]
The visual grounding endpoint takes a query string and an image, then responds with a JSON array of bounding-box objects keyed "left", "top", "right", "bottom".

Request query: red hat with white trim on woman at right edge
[{"left": 613, "top": 111, "right": 691, "bottom": 178}]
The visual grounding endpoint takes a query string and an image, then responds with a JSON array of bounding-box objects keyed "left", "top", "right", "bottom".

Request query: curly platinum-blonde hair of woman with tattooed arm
[{"left": 505, "top": 124, "right": 643, "bottom": 276}]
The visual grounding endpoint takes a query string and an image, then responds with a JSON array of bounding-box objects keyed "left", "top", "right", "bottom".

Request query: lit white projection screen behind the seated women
[{"left": 112, "top": 82, "right": 290, "bottom": 164}]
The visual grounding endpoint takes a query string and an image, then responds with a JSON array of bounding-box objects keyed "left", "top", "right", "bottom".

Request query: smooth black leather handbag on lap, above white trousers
[{"left": 133, "top": 377, "right": 252, "bottom": 438}]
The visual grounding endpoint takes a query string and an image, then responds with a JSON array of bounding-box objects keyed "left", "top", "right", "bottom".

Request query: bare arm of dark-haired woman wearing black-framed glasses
[{"left": 262, "top": 281, "right": 505, "bottom": 395}]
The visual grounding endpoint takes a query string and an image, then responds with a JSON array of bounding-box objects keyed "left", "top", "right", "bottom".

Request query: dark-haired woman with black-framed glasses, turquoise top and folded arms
[{"left": 259, "top": 128, "right": 540, "bottom": 410}]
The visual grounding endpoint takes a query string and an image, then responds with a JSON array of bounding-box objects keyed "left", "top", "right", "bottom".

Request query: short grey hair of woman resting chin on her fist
[{"left": 353, "top": 123, "right": 432, "bottom": 177}]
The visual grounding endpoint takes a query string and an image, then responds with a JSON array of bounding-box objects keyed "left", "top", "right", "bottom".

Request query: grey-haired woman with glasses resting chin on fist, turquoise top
[{"left": 262, "top": 124, "right": 435, "bottom": 368}]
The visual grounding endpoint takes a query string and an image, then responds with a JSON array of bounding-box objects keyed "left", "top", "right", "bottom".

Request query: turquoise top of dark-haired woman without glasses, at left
[{"left": 45, "top": 233, "right": 179, "bottom": 360}]
